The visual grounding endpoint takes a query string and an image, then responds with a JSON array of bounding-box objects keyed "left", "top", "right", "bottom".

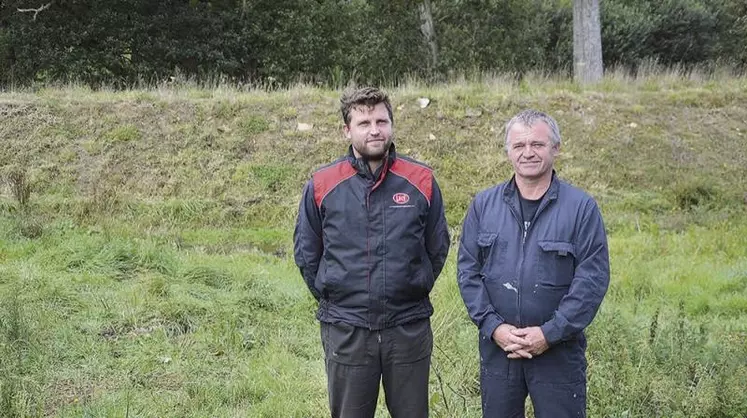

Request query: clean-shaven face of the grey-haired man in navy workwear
[{"left": 508, "top": 121, "right": 560, "bottom": 181}]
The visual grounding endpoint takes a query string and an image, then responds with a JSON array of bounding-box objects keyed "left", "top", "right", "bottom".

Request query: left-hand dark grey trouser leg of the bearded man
[{"left": 321, "top": 323, "right": 381, "bottom": 418}]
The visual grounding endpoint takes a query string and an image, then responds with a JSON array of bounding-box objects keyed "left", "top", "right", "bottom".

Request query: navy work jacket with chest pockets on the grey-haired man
[{"left": 457, "top": 173, "right": 610, "bottom": 346}]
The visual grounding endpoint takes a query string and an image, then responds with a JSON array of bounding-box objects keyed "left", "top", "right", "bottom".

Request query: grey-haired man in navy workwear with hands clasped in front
[{"left": 457, "top": 110, "right": 609, "bottom": 418}]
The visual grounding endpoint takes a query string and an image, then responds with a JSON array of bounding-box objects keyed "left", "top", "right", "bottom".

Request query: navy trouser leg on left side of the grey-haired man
[{"left": 480, "top": 335, "right": 528, "bottom": 418}]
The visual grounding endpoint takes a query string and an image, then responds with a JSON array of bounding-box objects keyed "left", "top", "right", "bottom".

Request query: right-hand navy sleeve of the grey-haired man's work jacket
[{"left": 540, "top": 200, "right": 610, "bottom": 345}]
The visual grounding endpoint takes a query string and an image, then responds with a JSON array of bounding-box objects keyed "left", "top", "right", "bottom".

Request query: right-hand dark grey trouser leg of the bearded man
[{"left": 381, "top": 319, "right": 433, "bottom": 418}]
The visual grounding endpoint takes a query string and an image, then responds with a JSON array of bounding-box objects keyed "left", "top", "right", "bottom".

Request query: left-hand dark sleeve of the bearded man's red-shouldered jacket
[{"left": 293, "top": 180, "right": 324, "bottom": 300}]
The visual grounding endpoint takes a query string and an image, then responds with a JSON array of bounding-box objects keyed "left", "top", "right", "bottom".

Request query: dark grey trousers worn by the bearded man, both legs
[{"left": 321, "top": 319, "right": 433, "bottom": 418}]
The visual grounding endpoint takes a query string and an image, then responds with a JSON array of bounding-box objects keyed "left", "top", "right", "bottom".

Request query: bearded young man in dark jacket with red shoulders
[{"left": 294, "top": 88, "right": 449, "bottom": 418}]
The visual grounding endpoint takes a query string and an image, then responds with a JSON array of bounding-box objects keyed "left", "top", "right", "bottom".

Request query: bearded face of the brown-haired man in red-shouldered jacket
[{"left": 343, "top": 103, "right": 393, "bottom": 161}]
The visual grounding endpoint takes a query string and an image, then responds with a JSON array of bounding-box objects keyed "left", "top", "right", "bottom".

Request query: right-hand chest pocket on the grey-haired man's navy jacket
[{"left": 536, "top": 241, "right": 576, "bottom": 287}]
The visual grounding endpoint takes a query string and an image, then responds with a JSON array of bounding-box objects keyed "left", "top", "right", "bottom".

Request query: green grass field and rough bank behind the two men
[{"left": 0, "top": 73, "right": 747, "bottom": 418}]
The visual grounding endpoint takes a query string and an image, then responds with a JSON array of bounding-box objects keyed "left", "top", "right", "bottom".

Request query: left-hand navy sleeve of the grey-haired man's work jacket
[{"left": 457, "top": 198, "right": 505, "bottom": 338}]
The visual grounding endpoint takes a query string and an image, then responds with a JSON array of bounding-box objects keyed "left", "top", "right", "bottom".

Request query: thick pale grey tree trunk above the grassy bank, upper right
[{"left": 573, "top": 0, "right": 604, "bottom": 84}]
